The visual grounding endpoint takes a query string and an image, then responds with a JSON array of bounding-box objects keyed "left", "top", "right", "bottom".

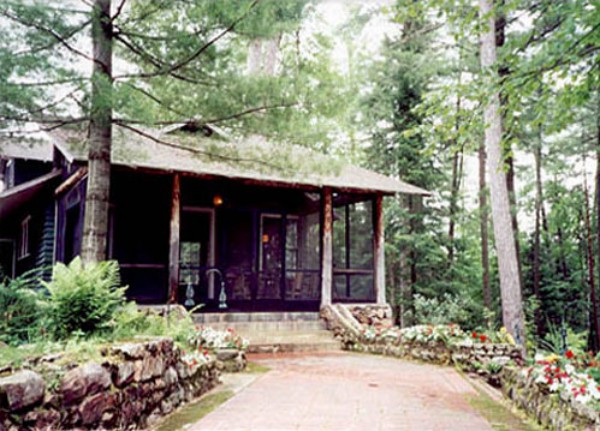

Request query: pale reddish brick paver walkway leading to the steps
[{"left": 188, "top": 353, "right": 493, "bottom": 431}]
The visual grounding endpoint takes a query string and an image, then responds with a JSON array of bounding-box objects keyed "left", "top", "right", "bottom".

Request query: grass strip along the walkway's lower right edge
[{"left": 468, "top": 385, "right": 542, "bottom": 431}]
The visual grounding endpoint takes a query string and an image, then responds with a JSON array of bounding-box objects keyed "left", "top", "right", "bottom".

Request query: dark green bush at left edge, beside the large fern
[{"left": 0, "top": 270, "right": 45, "bottom": 345}]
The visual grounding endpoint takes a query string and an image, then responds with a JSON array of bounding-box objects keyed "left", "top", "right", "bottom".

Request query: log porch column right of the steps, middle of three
[{"left": 321, "top": 187, "right": 333, "bottom": 307}]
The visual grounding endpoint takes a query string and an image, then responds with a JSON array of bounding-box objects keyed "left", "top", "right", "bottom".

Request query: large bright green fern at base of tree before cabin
[{"left": 44, "top": 258, "right": 127, "bottom": 339}]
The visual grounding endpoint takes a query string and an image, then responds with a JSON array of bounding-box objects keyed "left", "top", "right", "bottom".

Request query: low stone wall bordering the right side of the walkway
[{"left": 321, "top": 304, "right": 600, "bottom": 431}]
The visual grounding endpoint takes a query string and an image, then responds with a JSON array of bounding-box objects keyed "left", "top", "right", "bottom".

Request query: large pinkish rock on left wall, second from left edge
[{"left": 60, "top": 362, "right": 111, "bottom": 406}]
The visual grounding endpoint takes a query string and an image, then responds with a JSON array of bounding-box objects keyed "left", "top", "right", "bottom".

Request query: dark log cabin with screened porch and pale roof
[{"left": 0, "top": 122, "right": 428, "bottom": 311}]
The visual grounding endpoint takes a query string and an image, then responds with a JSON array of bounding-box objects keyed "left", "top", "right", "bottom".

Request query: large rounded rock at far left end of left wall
[{"left": 0, "top": 370, "right": 46, "bottom": 411}]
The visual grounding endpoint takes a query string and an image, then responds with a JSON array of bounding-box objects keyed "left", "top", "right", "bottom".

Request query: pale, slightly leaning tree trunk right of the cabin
[{"left": 479, "top": 0, "right": 524, "bottom": 344}]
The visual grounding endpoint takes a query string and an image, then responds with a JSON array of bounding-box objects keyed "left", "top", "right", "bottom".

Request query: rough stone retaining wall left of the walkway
[{"left": 0, "top": 338, "right": 220, "bottom": 431}]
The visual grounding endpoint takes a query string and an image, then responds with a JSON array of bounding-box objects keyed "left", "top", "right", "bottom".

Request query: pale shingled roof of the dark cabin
[{"left": 0, "top": 125, "right": 430, "bottom": 195}]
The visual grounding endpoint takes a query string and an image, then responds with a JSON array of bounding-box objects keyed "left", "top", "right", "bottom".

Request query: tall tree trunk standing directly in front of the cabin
[{"left": 81, "top": 0, "right": 113, "bottom": 262}]
